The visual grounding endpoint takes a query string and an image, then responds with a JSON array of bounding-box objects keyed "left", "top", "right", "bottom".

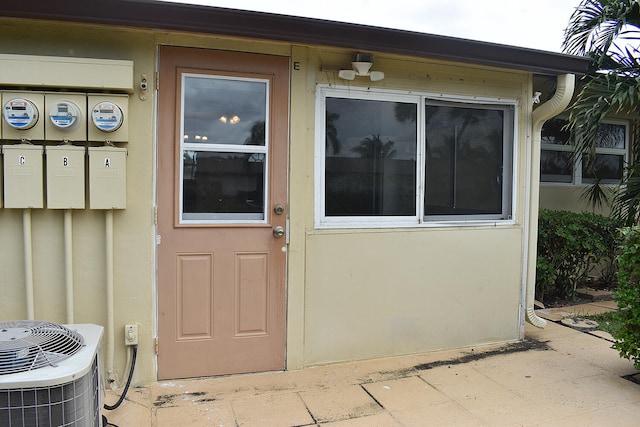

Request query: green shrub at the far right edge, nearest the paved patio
[{"left": 613, "top": 226, "right": 640, "bottom": 369}]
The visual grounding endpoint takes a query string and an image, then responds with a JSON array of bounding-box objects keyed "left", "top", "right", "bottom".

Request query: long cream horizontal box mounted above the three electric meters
[{"left": 0, "top": 54, "right": 133, "bottom": 93}]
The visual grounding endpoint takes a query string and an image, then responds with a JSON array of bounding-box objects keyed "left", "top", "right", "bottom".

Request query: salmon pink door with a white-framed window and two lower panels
[{"left": 158, "top": 47, "right": 289, "bottom": 379}]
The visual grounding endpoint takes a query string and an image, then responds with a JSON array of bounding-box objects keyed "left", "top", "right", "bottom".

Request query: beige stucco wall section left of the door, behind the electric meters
[{"left": 0, "top": 19, "right": 155, "bottom": 383}]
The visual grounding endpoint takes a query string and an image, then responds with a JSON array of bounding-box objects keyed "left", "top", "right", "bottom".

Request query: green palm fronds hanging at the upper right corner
[{"left": 563, "top": 0, "right": 640, "bottom": 219}]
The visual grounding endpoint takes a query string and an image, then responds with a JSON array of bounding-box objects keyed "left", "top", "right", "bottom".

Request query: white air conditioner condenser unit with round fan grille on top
[{"left": 0, "top": 320, "right": 104, "bottom": 427}]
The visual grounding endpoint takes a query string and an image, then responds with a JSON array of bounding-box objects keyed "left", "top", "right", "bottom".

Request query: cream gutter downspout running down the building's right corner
[{"left": 523, "top": 74, "right": 575, "bottom": 328}]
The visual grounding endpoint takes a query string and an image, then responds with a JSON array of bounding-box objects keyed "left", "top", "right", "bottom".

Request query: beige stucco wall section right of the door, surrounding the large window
[{"left": 287, "top": 47, "right": 530, "bottom": 367}]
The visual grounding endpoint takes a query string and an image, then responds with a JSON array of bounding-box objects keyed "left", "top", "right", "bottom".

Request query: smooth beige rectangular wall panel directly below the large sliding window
[{"left": 304, "top": 228, "right": 521, "bottom": 363}]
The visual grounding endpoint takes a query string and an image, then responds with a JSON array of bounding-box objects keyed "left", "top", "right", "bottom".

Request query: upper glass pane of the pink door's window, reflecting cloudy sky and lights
[{"left": 183, "top": 75, "right": 267, "bottom": 146}]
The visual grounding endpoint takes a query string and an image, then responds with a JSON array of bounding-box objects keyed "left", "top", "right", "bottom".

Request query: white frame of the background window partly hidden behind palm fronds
[{"left": 540, "top": 116, "right": 630, "bottom": 187}]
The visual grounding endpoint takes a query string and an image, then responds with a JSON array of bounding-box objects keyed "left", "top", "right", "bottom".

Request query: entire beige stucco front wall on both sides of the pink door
[{"left": 0, "top": 19, "right": 532, "bottom": 384}]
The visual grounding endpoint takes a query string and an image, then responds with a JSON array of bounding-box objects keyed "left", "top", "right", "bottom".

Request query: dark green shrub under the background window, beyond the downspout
[{"left": 536, "top": 209, "right": 620, "bottom": 301}]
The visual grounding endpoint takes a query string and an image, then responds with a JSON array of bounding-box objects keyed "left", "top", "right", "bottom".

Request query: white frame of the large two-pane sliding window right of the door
[{"left": 314, "top": 84, "right": 519, "bottom": 229}]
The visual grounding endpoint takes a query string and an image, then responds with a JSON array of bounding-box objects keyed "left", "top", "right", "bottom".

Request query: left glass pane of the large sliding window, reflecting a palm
[{"left": 325, "top": 98, "right": 417, "bottom": 216}]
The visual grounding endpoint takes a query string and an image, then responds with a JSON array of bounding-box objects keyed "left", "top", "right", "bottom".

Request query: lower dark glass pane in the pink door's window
[{"left": 182, "top": 151, "right": 265, "bottom": 220}]
